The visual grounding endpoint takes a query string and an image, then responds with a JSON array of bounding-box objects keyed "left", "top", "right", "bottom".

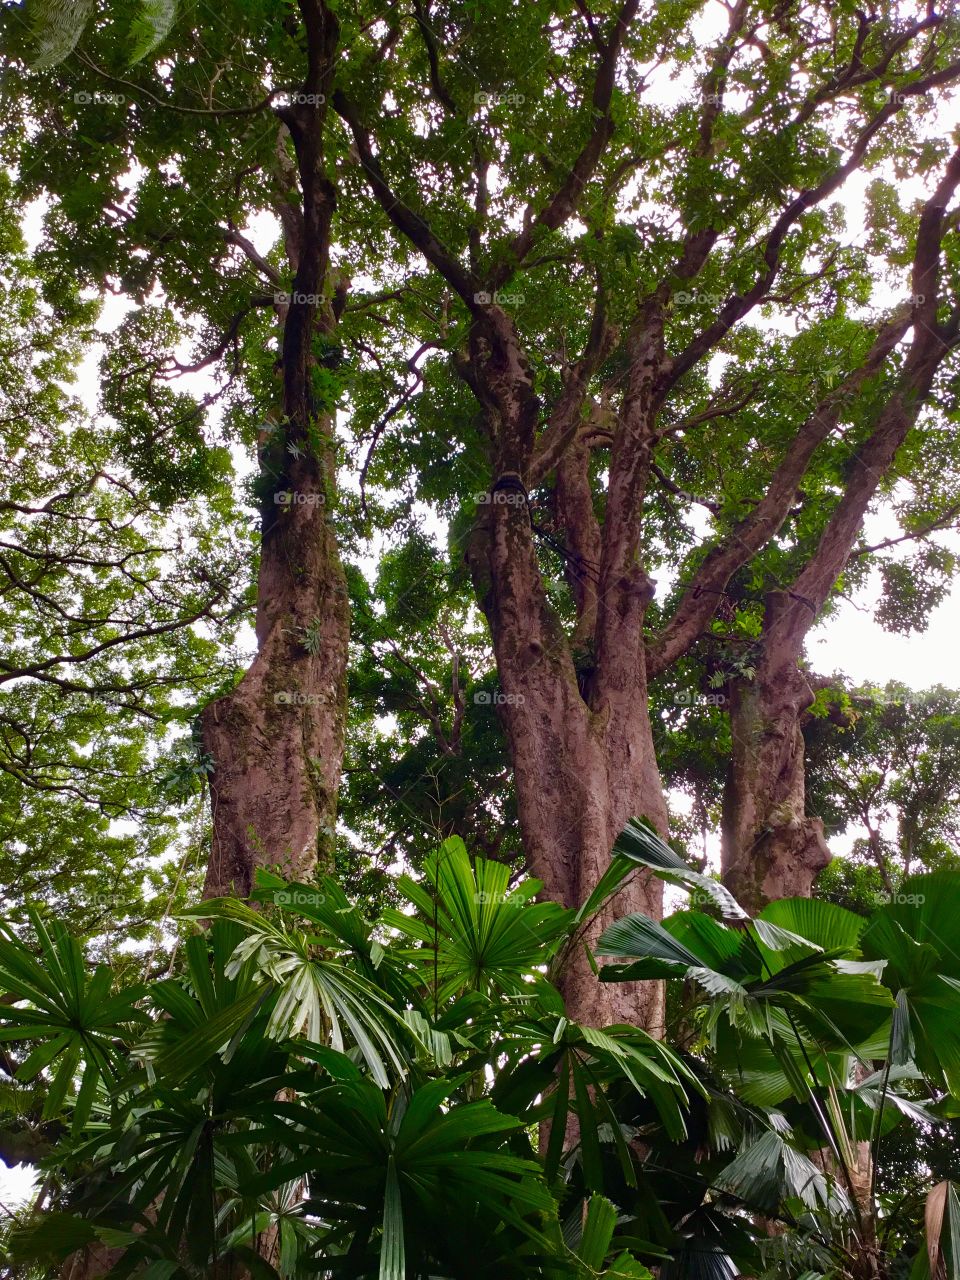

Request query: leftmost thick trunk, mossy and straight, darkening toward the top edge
[{"left": 204, "top": 0, "right": 349, "bottom": 897}]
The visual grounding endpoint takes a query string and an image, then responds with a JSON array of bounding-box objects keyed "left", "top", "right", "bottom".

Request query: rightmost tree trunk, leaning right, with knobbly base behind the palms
[{"left": 723, "top": 147, "right": 960, "bottom": 909}]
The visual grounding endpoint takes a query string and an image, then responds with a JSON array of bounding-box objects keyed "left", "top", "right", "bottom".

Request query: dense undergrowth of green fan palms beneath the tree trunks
[{"left": 0, "top": 823, "right": 960, "bottom": 1280}]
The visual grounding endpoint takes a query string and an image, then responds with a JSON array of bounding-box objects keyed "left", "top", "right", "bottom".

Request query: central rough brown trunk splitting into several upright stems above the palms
[{"left": 466, "top": 308, "right": 667, "bottom": 1032}]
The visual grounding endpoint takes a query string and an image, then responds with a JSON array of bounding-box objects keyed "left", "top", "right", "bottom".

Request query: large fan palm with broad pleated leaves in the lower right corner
[{"left": 598, "top": 823, "right": 960, "bottom": 1280}]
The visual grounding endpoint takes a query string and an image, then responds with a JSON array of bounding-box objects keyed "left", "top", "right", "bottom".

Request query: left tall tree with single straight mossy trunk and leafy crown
[{"left": 4, "top": 0, "right": 347, "bottom": 893}]
